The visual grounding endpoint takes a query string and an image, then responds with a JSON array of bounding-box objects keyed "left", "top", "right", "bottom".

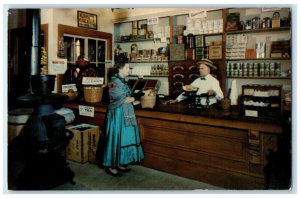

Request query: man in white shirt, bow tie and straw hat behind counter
[{"left": 167, "top": 58, "right": 224, "bottom": 105}]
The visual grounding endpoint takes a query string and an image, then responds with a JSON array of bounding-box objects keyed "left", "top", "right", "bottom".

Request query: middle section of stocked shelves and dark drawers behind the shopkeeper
[{"left": 169, "top": 9, "right": 225, "bottom": 96}]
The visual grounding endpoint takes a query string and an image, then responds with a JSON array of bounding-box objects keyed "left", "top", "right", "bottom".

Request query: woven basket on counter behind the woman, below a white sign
[{"left": 83, "top": 86, "right": 103, "bottom": 103}]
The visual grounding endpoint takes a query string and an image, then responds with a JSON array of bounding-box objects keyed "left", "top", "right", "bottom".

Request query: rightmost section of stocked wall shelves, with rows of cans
[{"left": 225, "top": 8, "right": 292, "bottom": 100}]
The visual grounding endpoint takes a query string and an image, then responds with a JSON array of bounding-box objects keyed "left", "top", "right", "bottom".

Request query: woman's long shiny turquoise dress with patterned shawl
[{"left": 102, "top": 74, "right": 144, "bottom": 168}]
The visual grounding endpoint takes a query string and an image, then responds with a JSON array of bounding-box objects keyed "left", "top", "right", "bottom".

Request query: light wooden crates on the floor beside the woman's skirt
[{"left": 66, "top": 124, "right": 100, "bottom": 163}]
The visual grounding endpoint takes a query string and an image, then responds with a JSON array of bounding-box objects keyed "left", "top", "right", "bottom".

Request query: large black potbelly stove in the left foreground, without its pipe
[{"left": 12, "top": 75, "right": 74, "bottom": 190}]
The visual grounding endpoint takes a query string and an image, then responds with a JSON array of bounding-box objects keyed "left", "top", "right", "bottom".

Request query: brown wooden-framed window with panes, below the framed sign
[{"left": 57, "top": 24, "right": 112, "bottom": 83}]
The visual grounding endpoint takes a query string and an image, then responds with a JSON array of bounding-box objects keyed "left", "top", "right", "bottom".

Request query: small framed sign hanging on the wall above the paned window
[{"left": 77, "top": 11, "right": 98, "bottom": 30}]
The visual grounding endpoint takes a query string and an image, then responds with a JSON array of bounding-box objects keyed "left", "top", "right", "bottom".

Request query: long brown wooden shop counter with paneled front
[{"left": 65, "top": 103, "right": 282, "bottom": 189}]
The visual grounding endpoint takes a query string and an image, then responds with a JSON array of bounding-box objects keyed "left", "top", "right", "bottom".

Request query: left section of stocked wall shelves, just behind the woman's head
[{"left": 114, "top": 16, "right": 170, "bottom": 95}]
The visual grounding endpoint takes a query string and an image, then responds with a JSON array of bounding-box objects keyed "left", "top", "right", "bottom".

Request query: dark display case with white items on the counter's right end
[{"left": 241, "top": 84, "right": 282, "bottom": 118}]
